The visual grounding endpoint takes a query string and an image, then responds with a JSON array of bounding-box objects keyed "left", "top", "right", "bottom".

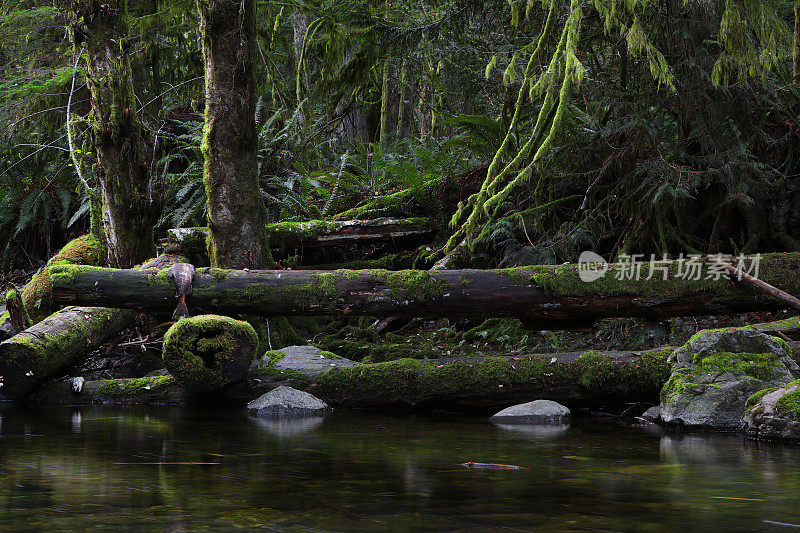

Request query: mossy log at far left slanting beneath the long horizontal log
[{"left": 0, "top": 256, "right": 183, "bottom": 399}]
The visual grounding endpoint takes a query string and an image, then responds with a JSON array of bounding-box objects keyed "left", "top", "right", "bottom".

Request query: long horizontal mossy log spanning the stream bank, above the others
[{"left": 51, "top": 254, "right": 800, "bottom": 322}]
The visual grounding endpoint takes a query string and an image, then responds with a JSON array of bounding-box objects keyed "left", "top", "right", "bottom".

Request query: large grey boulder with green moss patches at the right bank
[{"left": 661, "top": 328, "right": 798, "bottom": 430}]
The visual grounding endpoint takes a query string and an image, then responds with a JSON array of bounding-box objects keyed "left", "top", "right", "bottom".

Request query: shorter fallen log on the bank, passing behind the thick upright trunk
[{"left": 163, "top": 218, "right": 434, "bottom": 253}]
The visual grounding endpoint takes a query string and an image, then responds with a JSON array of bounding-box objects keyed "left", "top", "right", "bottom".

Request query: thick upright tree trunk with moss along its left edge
[{"left": 198, "top": 0, "right": 272, "bottom": 268}]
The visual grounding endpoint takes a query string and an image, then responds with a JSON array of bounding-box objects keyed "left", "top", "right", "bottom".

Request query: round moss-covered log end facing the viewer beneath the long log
[{"left": 163, "top": 315, "right": 258, "bottom": 392}]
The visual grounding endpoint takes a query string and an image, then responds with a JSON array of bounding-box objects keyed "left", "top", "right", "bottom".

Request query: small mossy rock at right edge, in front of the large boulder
[{"left": 742, "top": 382, "right": 800, "bottom": 441}]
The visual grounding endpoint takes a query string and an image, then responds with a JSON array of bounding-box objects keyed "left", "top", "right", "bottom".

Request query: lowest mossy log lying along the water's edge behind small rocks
[{"left": 25, "top": 347, "right": 673, "bottom": 412}]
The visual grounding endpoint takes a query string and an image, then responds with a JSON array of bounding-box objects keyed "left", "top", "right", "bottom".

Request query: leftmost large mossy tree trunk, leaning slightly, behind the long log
[{"left": 71, "top": 0, "right": 155, "bottom": 268}]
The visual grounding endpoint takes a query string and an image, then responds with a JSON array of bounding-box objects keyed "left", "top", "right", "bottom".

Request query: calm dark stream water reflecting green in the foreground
[{"left": 0, "top": 408, "right": 800, "bottom": 532}]
